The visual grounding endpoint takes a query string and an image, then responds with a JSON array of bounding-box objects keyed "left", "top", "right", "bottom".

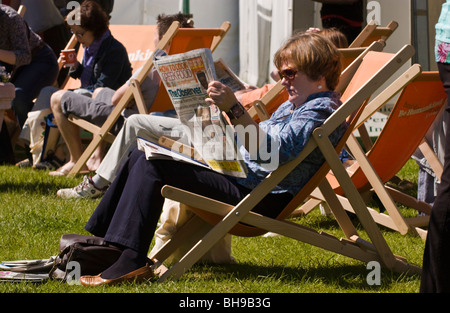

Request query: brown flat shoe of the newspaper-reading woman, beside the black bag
[{"left": 80, "top": 264, "right": 155, "bottom": 287}]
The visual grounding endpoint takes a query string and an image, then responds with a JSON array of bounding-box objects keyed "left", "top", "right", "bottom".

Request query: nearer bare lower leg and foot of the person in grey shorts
[{"left": 50, "top": 90, "right": 83, "bottom": 175}]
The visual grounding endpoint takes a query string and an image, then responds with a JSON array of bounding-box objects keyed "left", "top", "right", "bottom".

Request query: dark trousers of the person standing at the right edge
[{"left": 420, "top": 63, "right": 450, "bottom": 292}]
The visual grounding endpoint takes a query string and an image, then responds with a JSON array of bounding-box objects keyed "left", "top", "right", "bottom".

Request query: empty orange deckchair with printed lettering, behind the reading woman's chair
[{"left": 297, "top": 68, "right": 446, "bottom": 239}]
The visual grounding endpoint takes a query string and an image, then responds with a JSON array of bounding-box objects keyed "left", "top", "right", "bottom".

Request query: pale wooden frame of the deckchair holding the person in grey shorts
[{"left": 69, "top": 22, "right": 231, "bottom": 176}]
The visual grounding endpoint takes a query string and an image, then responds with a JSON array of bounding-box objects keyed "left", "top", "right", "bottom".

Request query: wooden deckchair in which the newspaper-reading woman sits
[{"left": 151, "top": 46, "right": 420, "bottom": 281}]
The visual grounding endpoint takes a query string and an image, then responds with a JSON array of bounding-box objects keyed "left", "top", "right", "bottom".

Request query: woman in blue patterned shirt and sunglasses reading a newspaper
[{"left": 80, "top": 33, "right": 346, "bottom": 286}]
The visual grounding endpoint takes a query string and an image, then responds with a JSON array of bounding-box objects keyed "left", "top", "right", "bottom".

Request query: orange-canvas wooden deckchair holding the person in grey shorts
[{"left": 69, "top": 22, "right": 230, "bottom": 176}]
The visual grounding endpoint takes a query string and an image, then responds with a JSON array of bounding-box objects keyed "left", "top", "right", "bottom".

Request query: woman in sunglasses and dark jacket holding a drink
[{"left": 16, "top": 1, "right": 132, "bottom": 169}]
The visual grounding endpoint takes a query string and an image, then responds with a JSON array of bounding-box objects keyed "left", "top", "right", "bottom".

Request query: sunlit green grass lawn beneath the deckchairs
[{"left": 0, "top": 161, "right": 424, "bottom": 293}]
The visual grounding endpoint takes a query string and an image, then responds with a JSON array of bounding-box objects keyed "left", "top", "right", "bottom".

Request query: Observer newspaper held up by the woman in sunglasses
[{"left": 150, "top": 49, "right": 247, "bottom": 177}]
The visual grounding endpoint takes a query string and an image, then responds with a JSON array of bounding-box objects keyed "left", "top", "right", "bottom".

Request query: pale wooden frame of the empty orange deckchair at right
[{"left": 296, "top": 64, "right": 445, "bottom": 239}]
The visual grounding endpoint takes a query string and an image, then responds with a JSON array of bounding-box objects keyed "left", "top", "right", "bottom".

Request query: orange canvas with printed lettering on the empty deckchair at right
[{"left": 336, "top": 72, "right": 446, "bottom": 190}]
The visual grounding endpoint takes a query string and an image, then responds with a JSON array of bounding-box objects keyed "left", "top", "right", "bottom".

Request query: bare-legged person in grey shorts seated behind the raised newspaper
[{"left": 46, "top": 13, "right": 192, "bottom": 175}]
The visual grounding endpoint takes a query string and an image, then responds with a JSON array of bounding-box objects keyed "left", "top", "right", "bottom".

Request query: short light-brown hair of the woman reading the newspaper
[{"left": 274, "top": 33, "right": 341, "bottom": 90}]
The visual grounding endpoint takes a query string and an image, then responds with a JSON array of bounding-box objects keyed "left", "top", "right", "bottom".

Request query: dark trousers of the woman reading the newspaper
[{"left": 85, "top": 150, "right": 292, "bottom": 254}]
